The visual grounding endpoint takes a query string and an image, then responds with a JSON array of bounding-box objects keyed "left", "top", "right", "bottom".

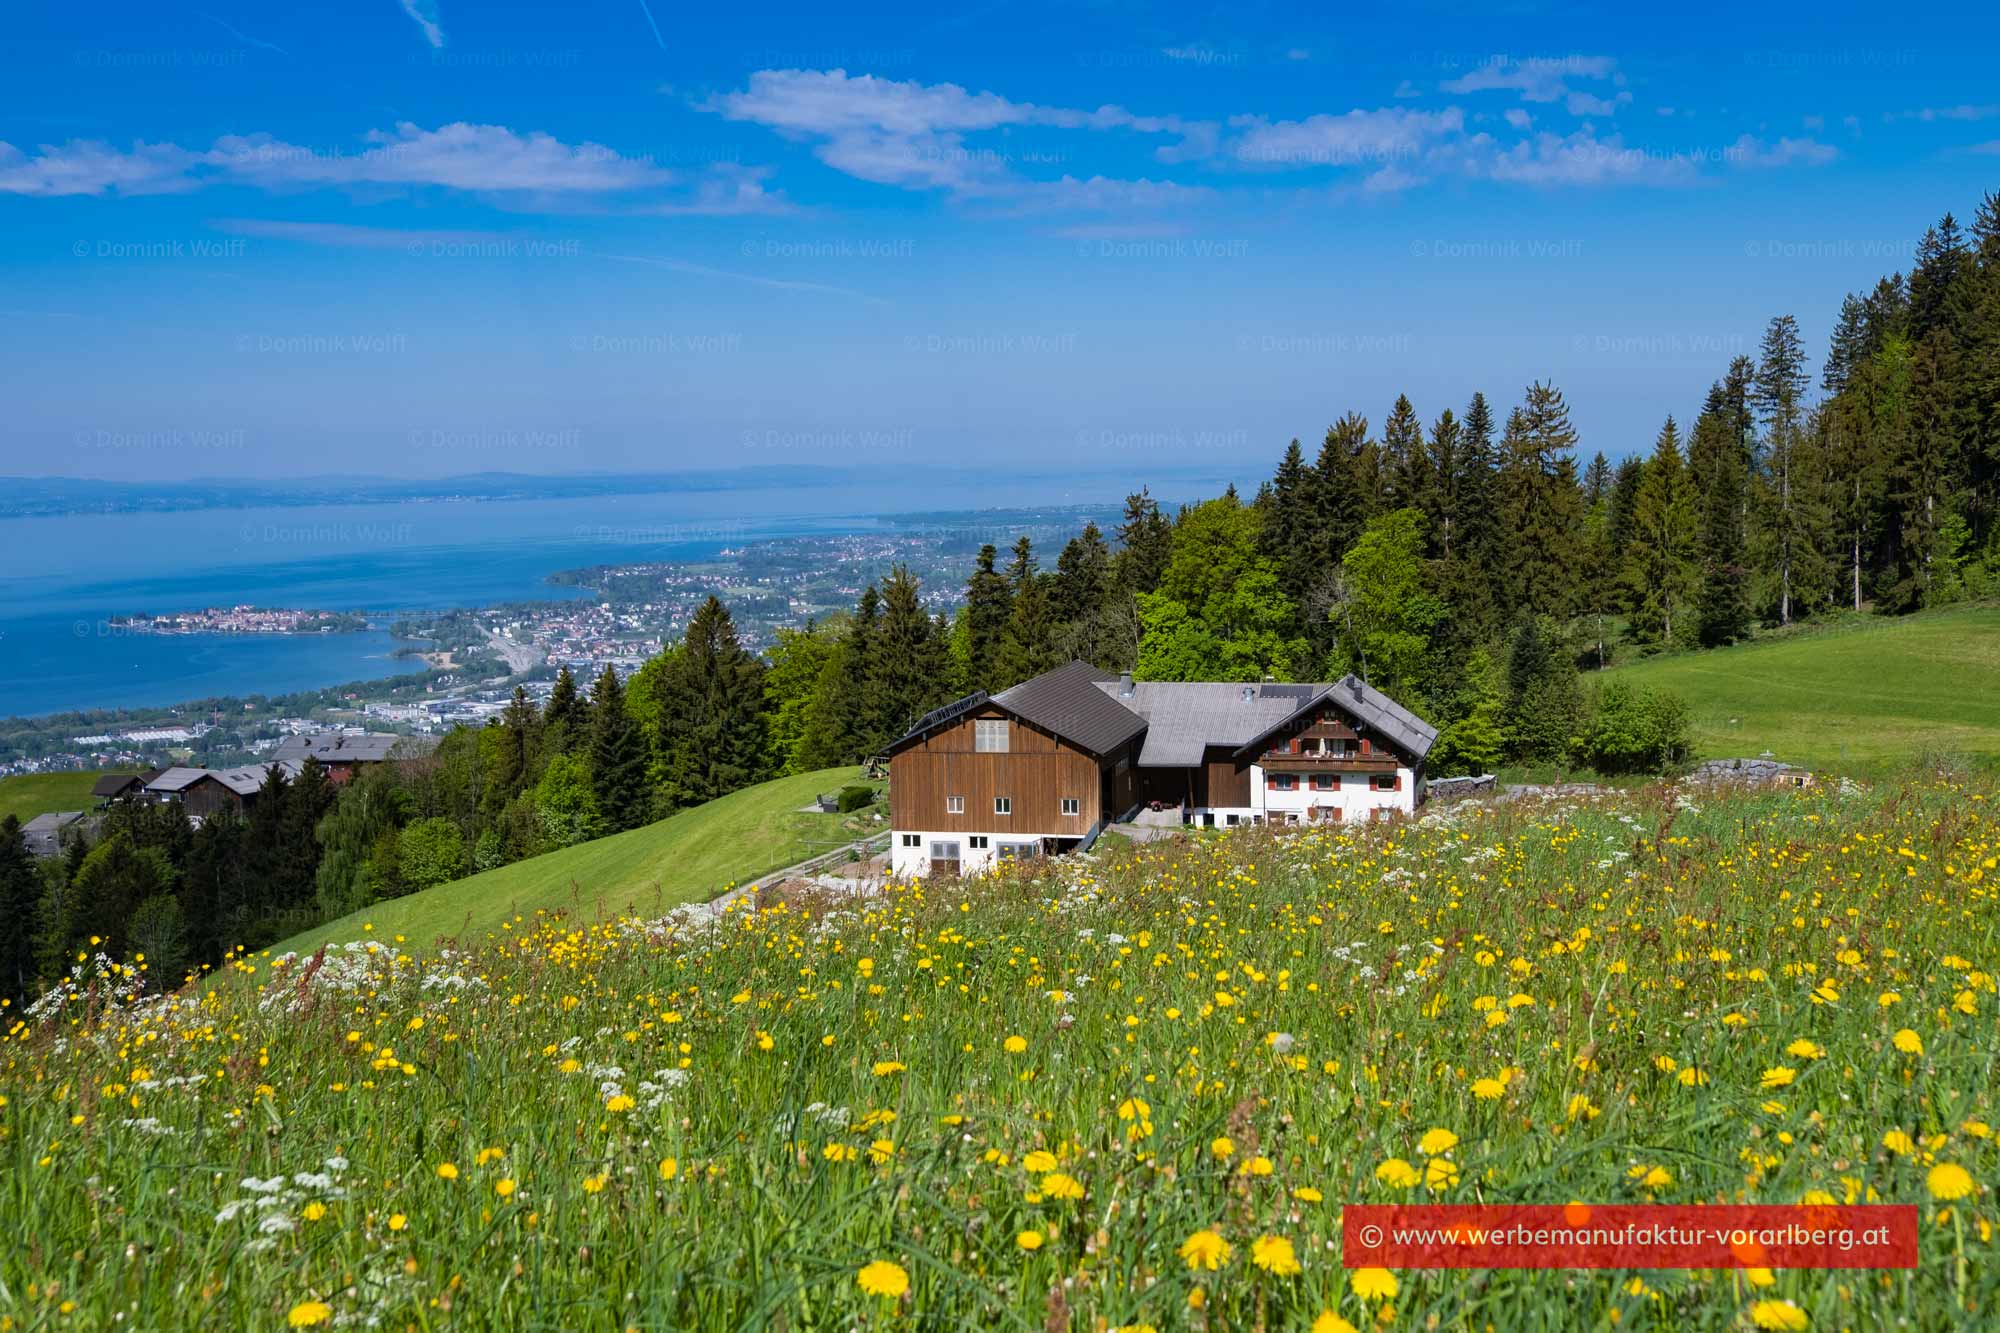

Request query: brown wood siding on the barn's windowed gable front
[{"left": 888, "top": 713, "right": 1104, "bottom": 837}]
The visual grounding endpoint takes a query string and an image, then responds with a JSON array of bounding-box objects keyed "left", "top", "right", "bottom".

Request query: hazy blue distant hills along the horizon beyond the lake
[{"left": 0, "top": 464, "right": 1226, "bottom": 518}]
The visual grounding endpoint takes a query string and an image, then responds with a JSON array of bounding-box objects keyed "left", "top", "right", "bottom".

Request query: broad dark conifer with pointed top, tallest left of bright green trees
[{"left": 656, "top": 596, "right": 768, "bottom": 811}]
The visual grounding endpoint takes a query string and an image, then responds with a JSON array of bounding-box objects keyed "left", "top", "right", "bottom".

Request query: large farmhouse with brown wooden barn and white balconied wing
[{"left": 888, "top": 662, "right": 1438, "bottom": 875}]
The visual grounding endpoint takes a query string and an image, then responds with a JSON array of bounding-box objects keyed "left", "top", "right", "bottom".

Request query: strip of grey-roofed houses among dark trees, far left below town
[{"left": 22, "top": 733, "right": 436, "bottom": 857}]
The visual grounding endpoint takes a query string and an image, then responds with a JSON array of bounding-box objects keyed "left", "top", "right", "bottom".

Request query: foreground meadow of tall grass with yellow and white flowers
[{"left": 0, "top": 779, "right": 2000, "bottom": 1333}]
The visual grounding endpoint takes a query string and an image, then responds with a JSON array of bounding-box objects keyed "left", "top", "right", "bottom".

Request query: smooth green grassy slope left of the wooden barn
[{"left": 272, "top": 769, "right": 882, "bottom": 953}]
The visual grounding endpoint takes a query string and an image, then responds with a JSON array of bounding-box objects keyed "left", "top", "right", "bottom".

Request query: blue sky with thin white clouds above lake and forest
[{"left": 0, "top": 0, "right": 2000, "bottom": 480}]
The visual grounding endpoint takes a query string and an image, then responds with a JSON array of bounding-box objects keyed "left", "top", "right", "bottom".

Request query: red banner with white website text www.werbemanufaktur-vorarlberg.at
[{"left": 1340, "top": 1203, "right": 1918, "bottom": 1269}]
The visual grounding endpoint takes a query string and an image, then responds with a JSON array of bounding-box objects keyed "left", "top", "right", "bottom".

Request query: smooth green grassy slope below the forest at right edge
[{"left": 1606, "top": 606, "right": 2000, "bottom": 775}]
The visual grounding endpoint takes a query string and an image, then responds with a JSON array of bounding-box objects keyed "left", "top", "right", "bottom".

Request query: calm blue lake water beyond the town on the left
[{"left": 0, "top": 478, "right": 1200, "bottom": 717}]
